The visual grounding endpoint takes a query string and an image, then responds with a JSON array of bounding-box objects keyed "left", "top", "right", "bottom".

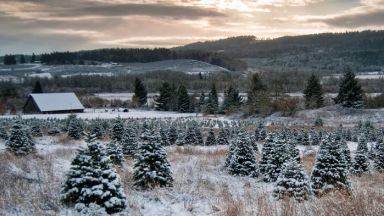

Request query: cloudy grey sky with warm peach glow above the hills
[{"left": 0, "top": 0, "right": 384, "bottom": 55}]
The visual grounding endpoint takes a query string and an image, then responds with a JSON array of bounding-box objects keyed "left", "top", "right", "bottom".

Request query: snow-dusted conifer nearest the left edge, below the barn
[{"left": 5, "top": 120, "right": 36, "bottom": 156}]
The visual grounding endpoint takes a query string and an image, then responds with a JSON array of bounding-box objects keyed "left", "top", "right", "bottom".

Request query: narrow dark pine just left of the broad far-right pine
[{"left": 304, "top": 74, "right": 324, "bottom": 109}]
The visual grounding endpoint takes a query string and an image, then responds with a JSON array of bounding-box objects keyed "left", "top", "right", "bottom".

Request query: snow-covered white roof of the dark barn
[{"left": 30, "top": 93, "right": 84, "bottom": 112}]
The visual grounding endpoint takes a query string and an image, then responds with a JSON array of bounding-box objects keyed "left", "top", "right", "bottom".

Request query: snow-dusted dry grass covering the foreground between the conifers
[{"left": 0, "top": 135, "right": 384, "bottom": 216}]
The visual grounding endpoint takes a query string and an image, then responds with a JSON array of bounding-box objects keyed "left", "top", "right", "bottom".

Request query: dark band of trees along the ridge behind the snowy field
[{"left": 37, "top": 48, "right": 247, "bottom": 71}]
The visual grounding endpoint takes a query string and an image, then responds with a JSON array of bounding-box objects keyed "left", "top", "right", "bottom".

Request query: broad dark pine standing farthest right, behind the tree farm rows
[{"left": 335, "top": 69, "right": 364, "bottom": 109}]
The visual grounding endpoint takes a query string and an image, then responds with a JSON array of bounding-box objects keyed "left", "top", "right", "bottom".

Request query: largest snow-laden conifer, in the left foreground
[{"left": 61, "top": 134, "right": 126, "bottom": 214}]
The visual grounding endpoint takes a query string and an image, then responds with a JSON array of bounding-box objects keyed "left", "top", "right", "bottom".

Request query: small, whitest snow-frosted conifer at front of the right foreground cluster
[{"left": 273, "top": 158, "right": 312, "bottom": 201}]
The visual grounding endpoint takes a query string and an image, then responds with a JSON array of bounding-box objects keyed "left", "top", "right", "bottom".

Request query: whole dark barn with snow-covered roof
[{"left": 23, "top": 92, "right": 84, "bottom": 113}]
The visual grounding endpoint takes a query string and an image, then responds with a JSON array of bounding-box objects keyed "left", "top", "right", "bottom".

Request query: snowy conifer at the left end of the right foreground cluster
[{"left": 228, "top": 132, "right": 259, "bottom": 177}]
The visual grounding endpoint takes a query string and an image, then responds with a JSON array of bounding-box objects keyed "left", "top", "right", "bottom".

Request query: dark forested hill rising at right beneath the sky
[{"left": 175, "top": 31, "right": 384, "bottom": 71}]
